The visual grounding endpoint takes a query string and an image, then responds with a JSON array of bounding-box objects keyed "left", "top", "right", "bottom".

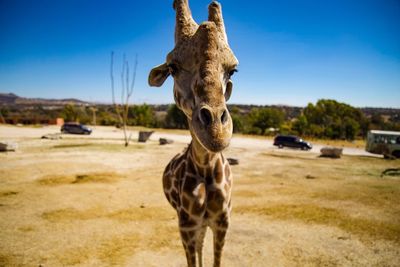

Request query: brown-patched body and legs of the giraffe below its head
[{"left": 163, "top": 143, "right": 232, "bottom": 262}]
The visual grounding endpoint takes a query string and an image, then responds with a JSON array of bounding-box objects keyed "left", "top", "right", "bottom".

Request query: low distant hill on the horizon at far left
[{"left": 0, "top": 93, "right": 91, "bottom": 106}]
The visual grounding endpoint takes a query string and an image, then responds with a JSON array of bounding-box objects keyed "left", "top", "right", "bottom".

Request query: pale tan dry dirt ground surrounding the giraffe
[{"left": 0, "top": 126, "right": 400, "bottom": 266}]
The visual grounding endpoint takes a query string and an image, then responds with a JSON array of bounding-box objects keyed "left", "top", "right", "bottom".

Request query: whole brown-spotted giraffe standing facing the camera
[{"left": 149, "top": 0, "right": 239, "bottom": 267}]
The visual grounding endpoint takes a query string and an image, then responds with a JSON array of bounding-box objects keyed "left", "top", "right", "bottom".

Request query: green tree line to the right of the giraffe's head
[{"left": 231, "top": 99, "right": 400, "bottom": 140}]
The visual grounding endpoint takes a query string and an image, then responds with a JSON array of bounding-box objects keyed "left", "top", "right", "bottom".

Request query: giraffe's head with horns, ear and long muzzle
[{"left": 149, "top": 0, "right": 238, "bottom": 152}]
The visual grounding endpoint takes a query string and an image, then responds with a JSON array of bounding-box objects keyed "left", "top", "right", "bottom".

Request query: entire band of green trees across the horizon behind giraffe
[{"left": 0, "top": 99, "right": 400, "bottom": 140}]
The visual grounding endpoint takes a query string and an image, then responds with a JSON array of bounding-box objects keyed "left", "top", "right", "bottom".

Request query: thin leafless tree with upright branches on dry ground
[{"left": 110, "top": 52, "right": 137, "bottom": 149}]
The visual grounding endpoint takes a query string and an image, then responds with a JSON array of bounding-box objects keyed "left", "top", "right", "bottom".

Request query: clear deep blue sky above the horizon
[{"left": 0, "top": 0, "right": 400, "bottom": 108}]
